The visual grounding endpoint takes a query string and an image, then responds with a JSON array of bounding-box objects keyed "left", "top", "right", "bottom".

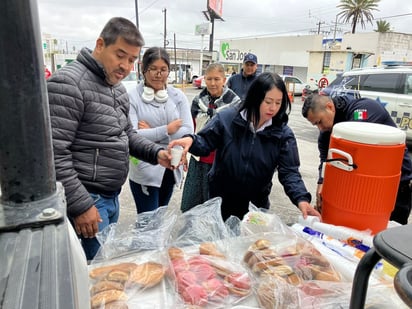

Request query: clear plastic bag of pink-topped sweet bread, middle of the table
[{"left": 168, "top": 242, "right": 252, "bottom": 308}]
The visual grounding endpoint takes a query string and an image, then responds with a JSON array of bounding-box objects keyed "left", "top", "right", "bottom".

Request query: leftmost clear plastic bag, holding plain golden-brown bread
[{"left": 89, "top": 251, "right": 174, "bottom": 309}]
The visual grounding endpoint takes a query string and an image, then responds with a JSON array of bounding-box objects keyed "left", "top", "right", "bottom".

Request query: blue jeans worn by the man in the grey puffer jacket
[{"left": 80, "top": 193, "right": 120, "bottom": 261}]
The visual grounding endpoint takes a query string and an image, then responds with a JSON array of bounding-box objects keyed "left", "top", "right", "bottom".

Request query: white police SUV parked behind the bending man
[{"left": 321, "top": 65, "right": 412, "bottom": 143}]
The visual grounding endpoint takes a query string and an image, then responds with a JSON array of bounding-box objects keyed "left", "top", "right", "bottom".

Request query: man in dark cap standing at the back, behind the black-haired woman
[{"left": 227, "top": 53, "right": 257, "bottom": 101}]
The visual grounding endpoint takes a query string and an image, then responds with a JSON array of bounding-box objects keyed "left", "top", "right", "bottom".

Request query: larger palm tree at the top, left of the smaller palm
[{"left": 336, "top": 0, "right": 380, "bottom": 33}]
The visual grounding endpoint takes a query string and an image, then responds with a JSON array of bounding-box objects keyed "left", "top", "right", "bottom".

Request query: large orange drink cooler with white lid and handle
[{"left": 322, "top": 121, "right": 405, "bottom": 234}]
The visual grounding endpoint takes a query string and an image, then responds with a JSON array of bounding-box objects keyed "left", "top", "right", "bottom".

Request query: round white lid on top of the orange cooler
[{"left": 332, "top": 121, "right": 406, "bottom": 145}]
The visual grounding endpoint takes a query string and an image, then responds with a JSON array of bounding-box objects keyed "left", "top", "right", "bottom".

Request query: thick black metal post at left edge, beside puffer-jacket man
[{"left": 0, "top": 0, "right": 56, "bottom": 204}]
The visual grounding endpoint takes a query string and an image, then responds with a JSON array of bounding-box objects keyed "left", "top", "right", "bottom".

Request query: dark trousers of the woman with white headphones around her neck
[{"left": 129, "top": 169, "right": 175, "bottom": 213}]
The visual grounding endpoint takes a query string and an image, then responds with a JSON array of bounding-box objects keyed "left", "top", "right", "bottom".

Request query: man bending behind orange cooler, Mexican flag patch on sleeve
[{"left": 302, "top": 94, "right": 412, "bottom": 224}]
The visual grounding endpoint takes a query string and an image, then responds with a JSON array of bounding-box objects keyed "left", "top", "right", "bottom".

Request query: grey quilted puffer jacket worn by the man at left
[{"left": 47, "top": 48, "right": 162, "bottom": 218}]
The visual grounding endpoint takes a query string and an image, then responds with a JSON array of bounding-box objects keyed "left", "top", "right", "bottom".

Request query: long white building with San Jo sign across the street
[{"left": 218, "top": 32, "right": 412, "bottom": 86}]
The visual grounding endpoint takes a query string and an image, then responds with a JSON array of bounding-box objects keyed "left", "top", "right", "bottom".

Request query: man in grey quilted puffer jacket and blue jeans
[{"left": 47, "top": 17, "right": 170, "bottom": 260}]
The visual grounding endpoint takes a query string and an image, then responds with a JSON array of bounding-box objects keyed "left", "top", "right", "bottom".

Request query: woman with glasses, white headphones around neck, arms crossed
[{"left": 129, "top": 47, "right": 193, "bottom": 213}]
